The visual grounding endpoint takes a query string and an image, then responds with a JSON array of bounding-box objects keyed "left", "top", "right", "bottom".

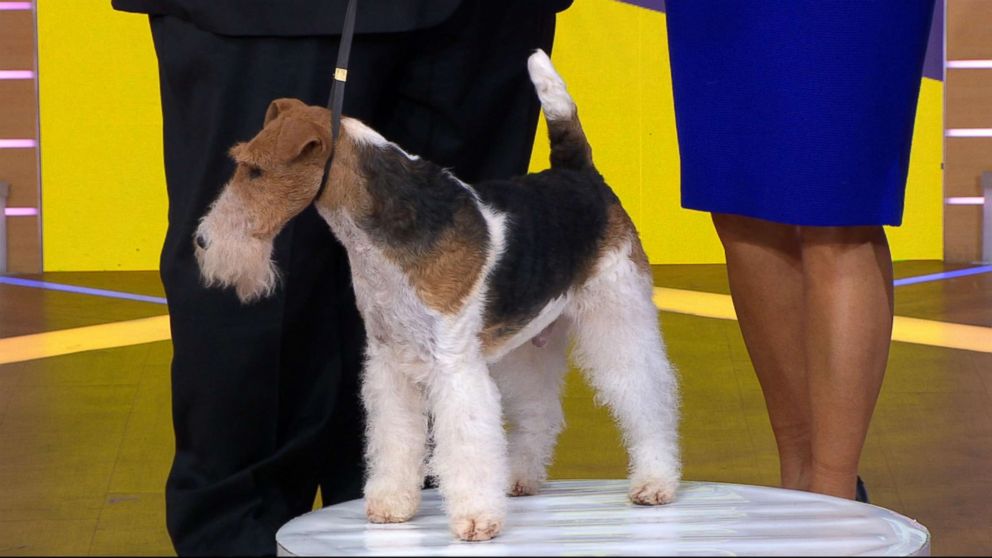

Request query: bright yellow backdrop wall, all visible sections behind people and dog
[{"left": 38, "top": 0, "right": 943, "bottom": 271}]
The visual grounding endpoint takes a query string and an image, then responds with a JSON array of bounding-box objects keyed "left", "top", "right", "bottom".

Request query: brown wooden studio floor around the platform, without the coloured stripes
[{"left": 0, "top": 262, "right": 992, "bottom": 555}]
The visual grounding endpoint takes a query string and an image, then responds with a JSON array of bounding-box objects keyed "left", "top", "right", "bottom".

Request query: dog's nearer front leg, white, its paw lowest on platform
[{"left": 428, "top": 355, "right": 509, "bottom": 541}]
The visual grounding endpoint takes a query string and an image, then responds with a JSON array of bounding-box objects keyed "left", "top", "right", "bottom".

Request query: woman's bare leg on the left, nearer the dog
[{"left": 713, "top": 213, "right": 812, "bottom": 490}]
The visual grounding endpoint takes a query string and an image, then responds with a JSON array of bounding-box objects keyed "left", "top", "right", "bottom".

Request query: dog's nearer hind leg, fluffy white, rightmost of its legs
[{"left": 566, "top": 243, "right": 681, "bottom": 505}]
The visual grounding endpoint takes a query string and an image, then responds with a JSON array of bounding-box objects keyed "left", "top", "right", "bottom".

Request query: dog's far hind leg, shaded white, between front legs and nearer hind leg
[{"left": 490, "top": 324, "right": 569, "bottom": 496}]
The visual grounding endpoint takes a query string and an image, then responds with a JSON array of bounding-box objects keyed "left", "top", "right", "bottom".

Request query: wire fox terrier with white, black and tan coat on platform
[{"left": 194, "top": 51, "right": 681, "bottom": 541}]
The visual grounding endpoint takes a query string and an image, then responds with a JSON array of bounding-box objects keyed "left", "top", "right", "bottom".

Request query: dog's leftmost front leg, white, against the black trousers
[{"left": 362, "top": 343, "right": 427, "bottom": 523}]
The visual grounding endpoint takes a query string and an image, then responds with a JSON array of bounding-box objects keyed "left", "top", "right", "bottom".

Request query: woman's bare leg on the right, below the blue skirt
[{"left": 801, "top": 227, "right": 893, "bottom": 498}]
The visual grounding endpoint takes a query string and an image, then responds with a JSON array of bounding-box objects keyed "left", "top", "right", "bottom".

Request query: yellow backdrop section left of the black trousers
[{"left": 38, "top": 0, "right": 167, "bottom": 271}]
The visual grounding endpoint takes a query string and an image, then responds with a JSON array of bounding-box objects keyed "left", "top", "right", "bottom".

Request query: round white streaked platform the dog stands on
[{"left": 276, "top": 480, "right": 930, "bottom": 556}]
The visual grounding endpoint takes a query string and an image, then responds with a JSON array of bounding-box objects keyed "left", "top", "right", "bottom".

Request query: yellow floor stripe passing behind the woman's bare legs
[{"left": 654, "top": 287, "right": 992, "bottom": 353}]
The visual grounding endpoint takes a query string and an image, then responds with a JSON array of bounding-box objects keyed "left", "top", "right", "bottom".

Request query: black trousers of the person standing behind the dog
[{"left": 151, "top": 0, "right": 555, "bottom": 555}]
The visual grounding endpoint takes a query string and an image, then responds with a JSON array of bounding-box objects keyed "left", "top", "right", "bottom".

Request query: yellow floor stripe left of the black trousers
[{"left": 0, "top": 316, "right": 172, "bottom": 364}]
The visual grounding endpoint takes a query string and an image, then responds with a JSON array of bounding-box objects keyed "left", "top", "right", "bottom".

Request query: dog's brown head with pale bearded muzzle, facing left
[{"left": 194, "top": 99, "right": 333, "bottom": 302}]
